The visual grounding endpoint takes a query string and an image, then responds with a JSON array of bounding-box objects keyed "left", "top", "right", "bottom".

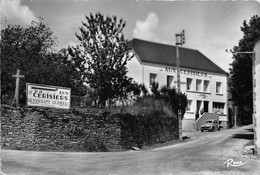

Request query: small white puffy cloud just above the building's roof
[{"left": 133, "top": 12, "right": 159, "bottom": 40}]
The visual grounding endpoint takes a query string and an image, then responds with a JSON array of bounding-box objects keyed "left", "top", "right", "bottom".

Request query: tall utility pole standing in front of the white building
[{"left": 175, "top": 30, "right": 185, "bottom": 140}]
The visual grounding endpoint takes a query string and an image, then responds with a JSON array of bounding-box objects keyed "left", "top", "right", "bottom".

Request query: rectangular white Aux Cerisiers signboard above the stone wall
[{"left": 26, "top": 83, "right": 71, "bottom": 109}]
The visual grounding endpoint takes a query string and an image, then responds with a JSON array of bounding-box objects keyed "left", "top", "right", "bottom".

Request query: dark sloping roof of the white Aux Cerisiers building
[{"left": 130, "top": 38, "right": 227, "bottom": 74}]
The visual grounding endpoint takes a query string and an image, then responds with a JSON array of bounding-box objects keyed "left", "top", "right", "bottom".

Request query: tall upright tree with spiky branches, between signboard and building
[{"left": 69, "top": 13, "right": 132, "bottom": 105}]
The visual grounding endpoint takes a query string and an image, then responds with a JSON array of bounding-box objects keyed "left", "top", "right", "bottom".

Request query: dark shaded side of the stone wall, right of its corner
[{"left": 120, "top": 111, "right": 179, "bottom": 148}]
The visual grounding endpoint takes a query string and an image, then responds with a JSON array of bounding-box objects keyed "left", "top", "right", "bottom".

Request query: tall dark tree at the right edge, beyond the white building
[{"left": 229, "top": 16, "right": 260, "bottom": 125}]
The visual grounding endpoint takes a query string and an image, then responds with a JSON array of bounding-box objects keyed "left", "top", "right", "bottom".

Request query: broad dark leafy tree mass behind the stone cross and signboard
[{"left": 1, "top": 19, "right": 84, "bottom": 104}]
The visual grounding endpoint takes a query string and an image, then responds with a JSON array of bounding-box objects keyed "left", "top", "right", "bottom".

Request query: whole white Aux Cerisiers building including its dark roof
[{"left": 127, "top": 39, "right": 228, "bottom": 131}]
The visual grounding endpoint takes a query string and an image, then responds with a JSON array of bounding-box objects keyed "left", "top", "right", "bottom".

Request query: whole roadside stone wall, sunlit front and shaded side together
[{"left": 1, "top": 106, "right": 178, "bottom": 151}]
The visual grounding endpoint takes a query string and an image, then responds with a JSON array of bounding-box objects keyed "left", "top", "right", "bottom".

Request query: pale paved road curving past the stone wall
[{"left": 1, "top": 126, "right": 260, "bottom": 175}]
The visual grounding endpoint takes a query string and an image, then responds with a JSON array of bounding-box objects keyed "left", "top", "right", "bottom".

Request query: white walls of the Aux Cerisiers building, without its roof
[{"left": 127, "top": 51, "right": 228, "bottom": 130}]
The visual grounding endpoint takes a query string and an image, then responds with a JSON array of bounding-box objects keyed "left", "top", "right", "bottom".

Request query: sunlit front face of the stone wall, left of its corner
[{"left": 1, "top": 106, "right": 122, "bottom": 151}]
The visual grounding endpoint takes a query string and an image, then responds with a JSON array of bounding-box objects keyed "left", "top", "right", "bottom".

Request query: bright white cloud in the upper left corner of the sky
[{"left": 0, "top": 0, "right": 38, "bottom": 24}]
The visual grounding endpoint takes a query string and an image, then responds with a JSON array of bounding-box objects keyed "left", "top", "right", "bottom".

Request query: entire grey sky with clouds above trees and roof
[{"left": 0, "top": 0, "right": 260, "bottom": 72}]
